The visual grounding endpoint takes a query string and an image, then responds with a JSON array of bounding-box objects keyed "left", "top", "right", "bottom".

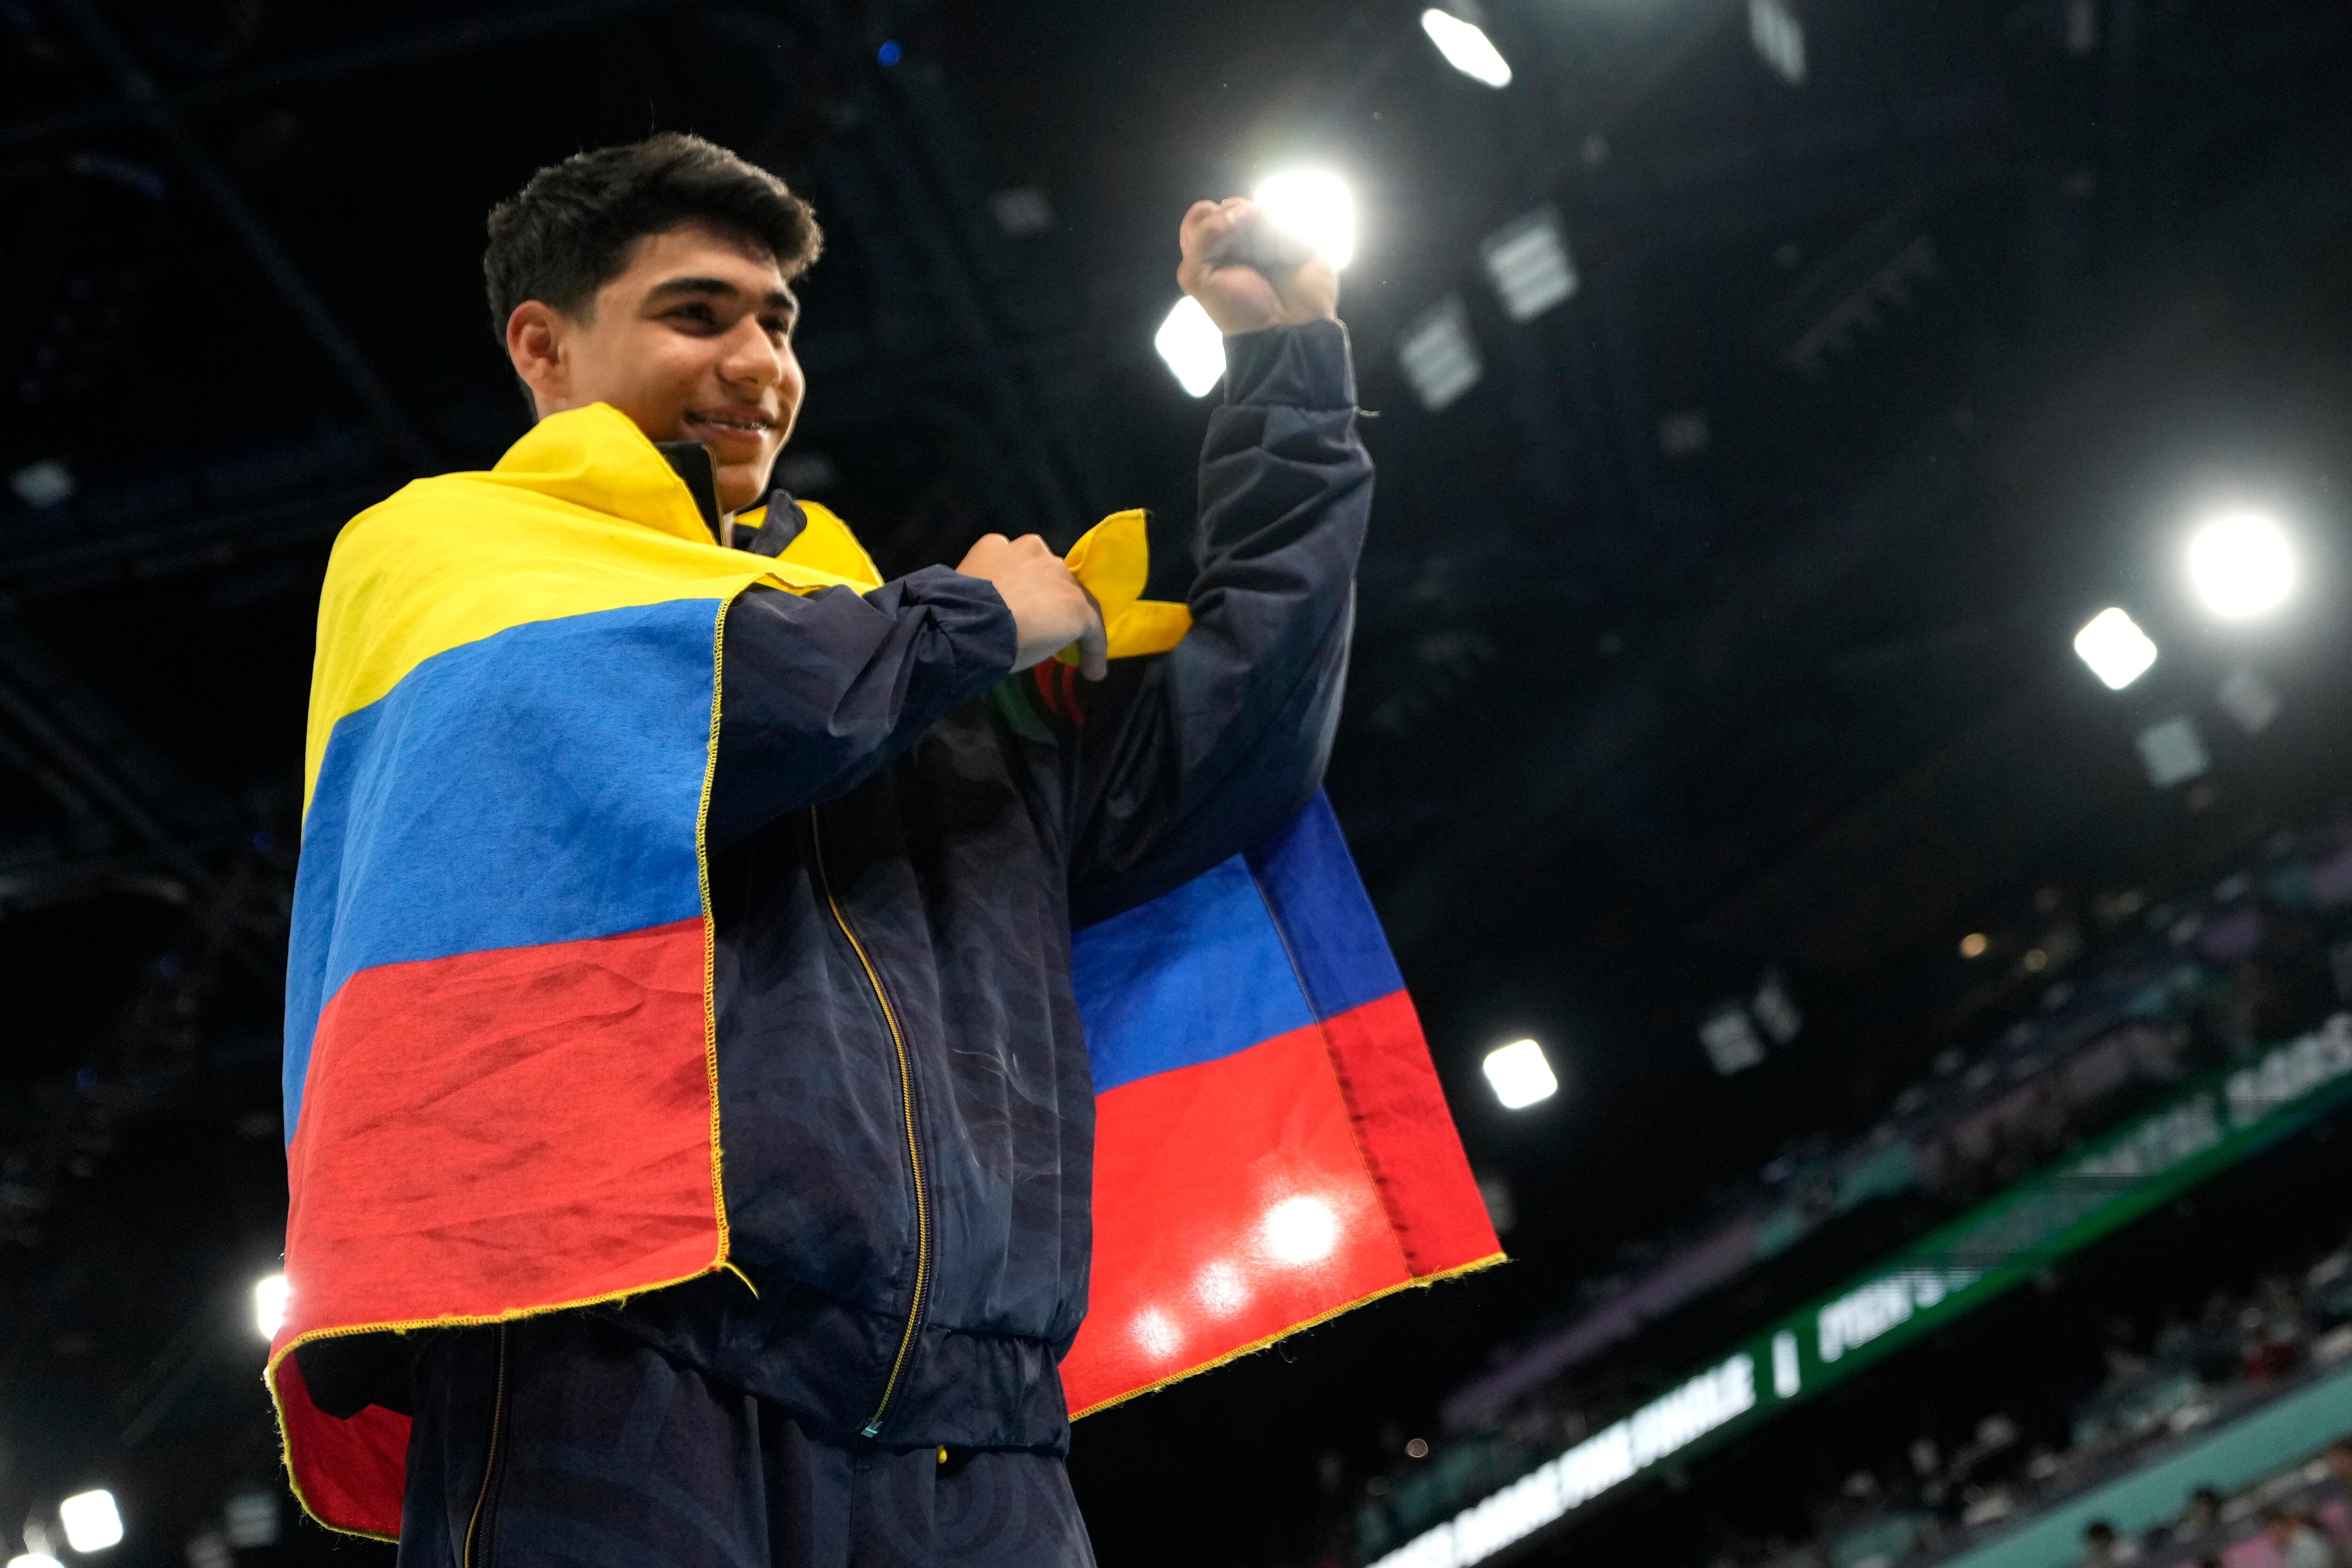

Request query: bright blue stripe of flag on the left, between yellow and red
[{"left": 285, "top": 600, "right": 722, "bottom": 1140}]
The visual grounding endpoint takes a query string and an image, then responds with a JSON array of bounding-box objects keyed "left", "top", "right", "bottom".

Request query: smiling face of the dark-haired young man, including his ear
[{"left": 506, "top": 223, "right": 807, "bottom": 513}]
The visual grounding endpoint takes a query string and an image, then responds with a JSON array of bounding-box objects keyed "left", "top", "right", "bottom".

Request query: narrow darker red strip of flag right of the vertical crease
[{"left": 1324, "top": 992, "right": 1503, "bottom": 1276}]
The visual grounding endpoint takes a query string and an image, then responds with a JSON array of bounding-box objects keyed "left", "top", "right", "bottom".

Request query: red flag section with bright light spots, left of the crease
[{"left": 1061, "top": 1025, "right": 1409, "bottom": 1410}]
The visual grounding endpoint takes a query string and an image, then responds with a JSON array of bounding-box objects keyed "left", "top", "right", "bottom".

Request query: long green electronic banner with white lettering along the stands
[{"left": 1374, "top": 1013, "right": 2352, "bottom": 1568}]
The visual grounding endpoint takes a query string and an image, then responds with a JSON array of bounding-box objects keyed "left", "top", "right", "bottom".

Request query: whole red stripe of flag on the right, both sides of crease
[{"left": 1061, "top": 992, "right": 1501, "bottom": 1415}]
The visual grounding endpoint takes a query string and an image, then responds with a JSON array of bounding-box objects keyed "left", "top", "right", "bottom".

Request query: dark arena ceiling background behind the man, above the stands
[{"left": 0, "top": 0, "right": 2352, "bottom": 1568}]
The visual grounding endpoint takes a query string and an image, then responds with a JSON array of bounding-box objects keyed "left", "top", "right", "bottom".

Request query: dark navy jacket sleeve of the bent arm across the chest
[{"left": 706, "top": 567, "right": 1018, "bottom": 848}]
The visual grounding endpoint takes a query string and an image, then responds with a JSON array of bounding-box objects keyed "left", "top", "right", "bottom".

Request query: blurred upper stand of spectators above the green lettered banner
[{"left": 1442, "top": 823, "right": 2352, "bottom": 1432}]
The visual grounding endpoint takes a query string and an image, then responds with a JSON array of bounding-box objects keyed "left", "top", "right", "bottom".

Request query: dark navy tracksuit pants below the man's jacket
[{"left": 400, "top": 1312, "right": 1094, "bottom": 1568}]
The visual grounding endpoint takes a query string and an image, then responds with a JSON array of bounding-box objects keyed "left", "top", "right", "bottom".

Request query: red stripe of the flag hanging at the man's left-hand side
[{"left": 287, "top": 919, "right": 722, "bottom": 1338}]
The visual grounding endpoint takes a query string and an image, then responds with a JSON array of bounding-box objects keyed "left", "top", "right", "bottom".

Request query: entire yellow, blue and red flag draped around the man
[{"left": 268, "top": 404, "right": 1496, "bottom": 1535}]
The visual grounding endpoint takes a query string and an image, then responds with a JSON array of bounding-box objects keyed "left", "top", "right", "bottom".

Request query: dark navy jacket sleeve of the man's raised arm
[{"left": 1063, "top": 322, "right": 1371, "bottom": 924}]
